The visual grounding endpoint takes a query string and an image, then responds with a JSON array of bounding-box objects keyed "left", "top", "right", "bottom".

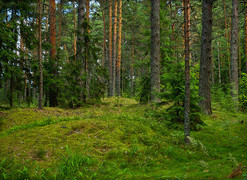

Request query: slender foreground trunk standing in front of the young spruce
[{"left": 184, "top": 0, "right": 190, "bottom": 144}]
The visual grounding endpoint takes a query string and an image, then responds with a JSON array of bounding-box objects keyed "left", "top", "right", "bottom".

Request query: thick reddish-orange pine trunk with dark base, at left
[{"left": 49, "top": 0, "right": 58, "bottom": 107}]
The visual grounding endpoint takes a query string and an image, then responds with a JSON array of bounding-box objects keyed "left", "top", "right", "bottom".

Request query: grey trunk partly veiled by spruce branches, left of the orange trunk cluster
[{"left": 76, "top": 0, "right": 86, "bottom": 102}]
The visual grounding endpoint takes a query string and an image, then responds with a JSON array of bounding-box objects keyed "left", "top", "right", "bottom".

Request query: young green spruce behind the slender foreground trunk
[{"left": 162, "top": 62, "right": 205, "bottom": 130}]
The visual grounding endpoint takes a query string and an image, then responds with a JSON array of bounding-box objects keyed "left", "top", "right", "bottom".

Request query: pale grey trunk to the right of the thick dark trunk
[{"left": 231, "top": 0, "right": 239, "bottom": 101}]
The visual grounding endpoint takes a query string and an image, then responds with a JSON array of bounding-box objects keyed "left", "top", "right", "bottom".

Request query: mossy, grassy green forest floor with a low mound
[{"left": 0, "top": 98, "right": 247, "bottom": 179}]
